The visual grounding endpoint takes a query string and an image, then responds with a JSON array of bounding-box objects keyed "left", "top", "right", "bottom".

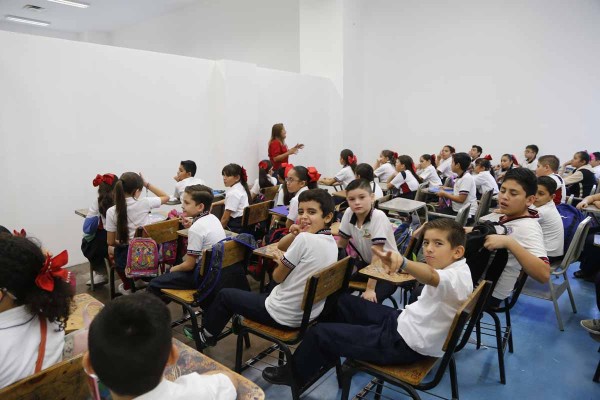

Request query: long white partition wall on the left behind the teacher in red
[{"left": 0, "top": 32, "right": 341, "bottom": 265}]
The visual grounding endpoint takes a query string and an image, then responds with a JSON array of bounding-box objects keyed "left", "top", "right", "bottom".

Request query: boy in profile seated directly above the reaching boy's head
[{"left": 436, "top": 153, "right": 477, "bottom": 217}]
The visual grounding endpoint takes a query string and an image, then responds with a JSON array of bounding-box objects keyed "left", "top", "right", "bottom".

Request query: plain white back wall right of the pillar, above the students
[{"left": 344, "top": 0, "right": 600, "bottom": 160}]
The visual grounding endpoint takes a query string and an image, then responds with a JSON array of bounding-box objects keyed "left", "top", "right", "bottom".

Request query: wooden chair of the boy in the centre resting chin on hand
[{"left": 233, "top": 257, "right": 351, "bottom": 400}]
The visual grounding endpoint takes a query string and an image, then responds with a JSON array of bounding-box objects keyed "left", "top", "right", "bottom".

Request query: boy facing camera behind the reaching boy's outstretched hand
[{"left": 337, "top": 180, "right": 398, "bottom": 303}]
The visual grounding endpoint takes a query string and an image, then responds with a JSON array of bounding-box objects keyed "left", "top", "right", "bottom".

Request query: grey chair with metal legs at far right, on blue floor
[{"left": 523, "top": 217, "right": 592, "bottom": 331}]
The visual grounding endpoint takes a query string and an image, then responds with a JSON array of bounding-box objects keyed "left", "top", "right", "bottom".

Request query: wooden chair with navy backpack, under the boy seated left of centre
[{"left": 161, "top": 240, "right": 252, "bottom": 351}]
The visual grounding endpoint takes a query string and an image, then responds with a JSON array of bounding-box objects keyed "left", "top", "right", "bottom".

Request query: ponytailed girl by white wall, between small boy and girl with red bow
[{"left": 221, "top": 164, "right": 250, "bottom": 233}]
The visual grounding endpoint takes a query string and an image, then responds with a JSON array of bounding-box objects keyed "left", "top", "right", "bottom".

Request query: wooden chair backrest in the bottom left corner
[{"left": 0, "top": 354, "right": 90, "bottom": 400}]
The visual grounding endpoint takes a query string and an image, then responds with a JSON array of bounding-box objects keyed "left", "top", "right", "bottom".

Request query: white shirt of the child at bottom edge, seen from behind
[{"left": 135, "top": 372, "right": 237, "bottom": 400}]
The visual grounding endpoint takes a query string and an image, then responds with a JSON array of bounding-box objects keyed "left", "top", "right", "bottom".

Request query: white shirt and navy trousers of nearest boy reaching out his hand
[{"left": 293, "top": 259, "right": 473, "bottom": 385}]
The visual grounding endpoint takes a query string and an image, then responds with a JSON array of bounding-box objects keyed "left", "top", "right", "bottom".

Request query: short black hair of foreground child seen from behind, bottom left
[{"left": 88, "top": 293, "right": 172, "bottom": 397}]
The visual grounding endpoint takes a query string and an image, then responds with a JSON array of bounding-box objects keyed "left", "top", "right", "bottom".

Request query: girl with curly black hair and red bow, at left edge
[{"left": 0, "top": 233, "right": 73, "bottom": 388}]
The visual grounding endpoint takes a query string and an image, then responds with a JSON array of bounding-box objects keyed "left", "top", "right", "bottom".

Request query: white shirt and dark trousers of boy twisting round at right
[{"left": 492, "top": 209, "right": 549, "bottom": 301}]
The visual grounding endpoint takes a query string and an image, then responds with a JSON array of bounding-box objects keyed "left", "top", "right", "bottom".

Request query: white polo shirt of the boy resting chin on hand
[{"left": 265, "top": 229, "right": 338, "bottom": 328}]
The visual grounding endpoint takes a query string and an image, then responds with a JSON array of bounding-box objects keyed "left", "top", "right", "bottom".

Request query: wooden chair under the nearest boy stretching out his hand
[{"left": 340, "top": 281, "right": 490, "bottom": 400}]
